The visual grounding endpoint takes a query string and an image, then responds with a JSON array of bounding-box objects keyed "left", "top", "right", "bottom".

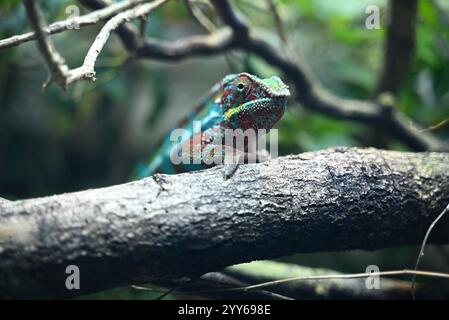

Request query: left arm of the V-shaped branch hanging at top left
[{"left": 23, "top": 0, "right": 69, "bottom": 90}]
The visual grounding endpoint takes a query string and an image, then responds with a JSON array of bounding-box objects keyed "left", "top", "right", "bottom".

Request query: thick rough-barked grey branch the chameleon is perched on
[{"left": 0, "top": 148, "right": 449, "bottom": 298}]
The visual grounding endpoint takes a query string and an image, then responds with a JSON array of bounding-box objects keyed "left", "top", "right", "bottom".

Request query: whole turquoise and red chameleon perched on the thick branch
[{"left": 135, "top": 72, "right": 290, "bottom": 179}]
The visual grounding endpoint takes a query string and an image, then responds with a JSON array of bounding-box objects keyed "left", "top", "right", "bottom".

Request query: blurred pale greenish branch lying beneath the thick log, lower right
[{"left": 156, "top": 260, "right": 449, "bottom": 300}]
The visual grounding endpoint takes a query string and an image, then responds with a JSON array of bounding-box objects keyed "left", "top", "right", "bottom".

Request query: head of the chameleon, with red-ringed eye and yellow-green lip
[{"left": 221, "top": 73, "right": 290, "bottom": 132}]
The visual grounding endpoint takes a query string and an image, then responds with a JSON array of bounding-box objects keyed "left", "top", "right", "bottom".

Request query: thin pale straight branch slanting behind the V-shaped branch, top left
[{"left": 0, "top": 0, "right": 148, "bottom": 49}]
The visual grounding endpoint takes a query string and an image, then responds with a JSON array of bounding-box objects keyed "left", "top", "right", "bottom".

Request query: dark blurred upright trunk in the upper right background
[{"left": 376, "top": 0, "right": 418, "bottom": 94}]
